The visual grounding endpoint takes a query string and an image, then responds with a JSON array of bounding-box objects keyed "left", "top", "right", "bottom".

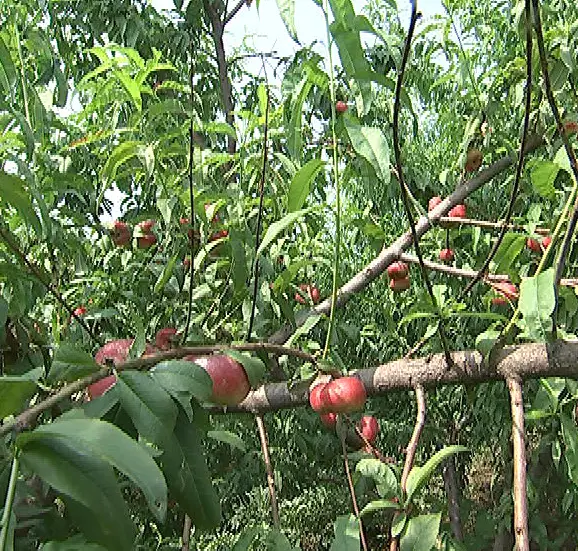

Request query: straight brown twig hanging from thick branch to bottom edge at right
[{"left": 508, "top": 377, "right": 530, "bottom": 551}]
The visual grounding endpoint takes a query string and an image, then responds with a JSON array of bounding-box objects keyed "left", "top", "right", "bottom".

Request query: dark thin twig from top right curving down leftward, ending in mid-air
[{"left": 461, "top": 0, "right": 532, "bottom": 297}]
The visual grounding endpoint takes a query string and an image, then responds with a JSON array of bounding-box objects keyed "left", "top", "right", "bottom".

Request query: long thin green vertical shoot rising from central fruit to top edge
[{"left": 323, "top": 0, "right": 341, "bottom": 359}]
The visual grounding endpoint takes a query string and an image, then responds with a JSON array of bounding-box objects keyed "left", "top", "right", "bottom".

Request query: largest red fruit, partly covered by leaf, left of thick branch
[{"left": 184, "top": 354, "right": 251, "bottom": 406}]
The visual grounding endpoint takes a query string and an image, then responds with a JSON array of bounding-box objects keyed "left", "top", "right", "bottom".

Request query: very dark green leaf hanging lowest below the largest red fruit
[{"left": 159, "top": 411, "right": 221, "bottom": 530}]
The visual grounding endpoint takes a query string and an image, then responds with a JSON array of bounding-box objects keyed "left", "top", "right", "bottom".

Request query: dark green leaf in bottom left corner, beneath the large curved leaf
[{"left": 17, "top": 438, "right": 135, "bottom": 551}]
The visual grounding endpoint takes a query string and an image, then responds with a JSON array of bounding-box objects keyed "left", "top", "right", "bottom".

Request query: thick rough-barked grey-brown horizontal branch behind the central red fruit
[{"left": 219, "top": 341, "right": 578, "bottom": 413}]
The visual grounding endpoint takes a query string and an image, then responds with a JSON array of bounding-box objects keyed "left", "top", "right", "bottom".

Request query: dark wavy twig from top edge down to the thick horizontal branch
[{"left": 393, "top": 0, "right": 451, "bottom": 364}]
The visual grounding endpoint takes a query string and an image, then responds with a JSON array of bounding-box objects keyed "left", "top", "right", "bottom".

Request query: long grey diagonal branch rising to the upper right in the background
[{"left": 268, "top": 136, "right": 543, "bottom": 344}]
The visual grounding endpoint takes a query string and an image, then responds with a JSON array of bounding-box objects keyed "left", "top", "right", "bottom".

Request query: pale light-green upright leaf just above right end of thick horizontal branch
[{"left": 518, "top": 268, "right": 556, "bottom": 342}]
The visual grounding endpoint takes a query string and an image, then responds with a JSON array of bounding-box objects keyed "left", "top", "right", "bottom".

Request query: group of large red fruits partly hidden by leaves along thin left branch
[{"left": 87, "top": 327, "right": 251, "bottom": 406}]
